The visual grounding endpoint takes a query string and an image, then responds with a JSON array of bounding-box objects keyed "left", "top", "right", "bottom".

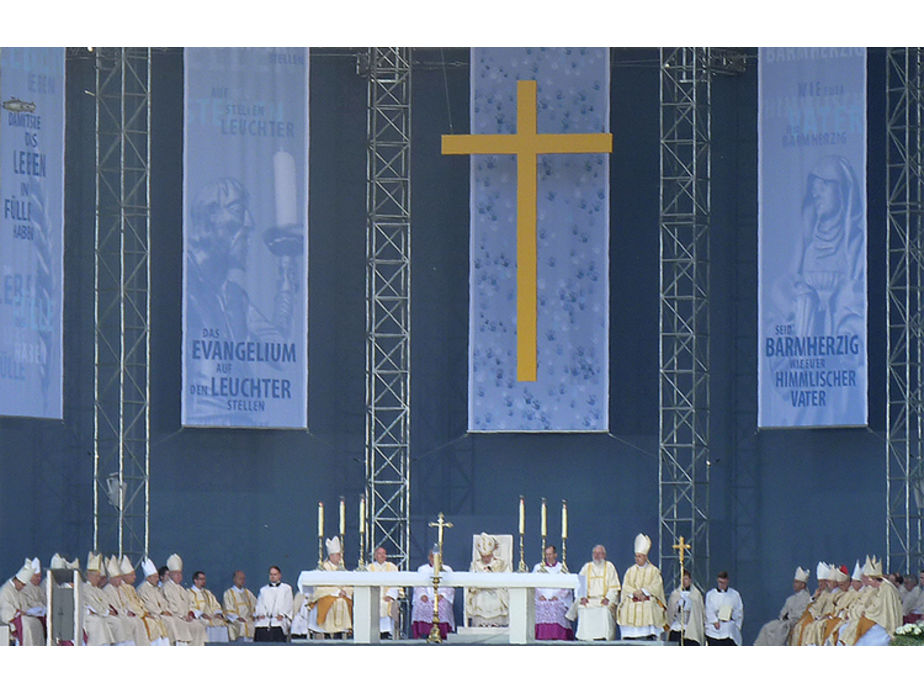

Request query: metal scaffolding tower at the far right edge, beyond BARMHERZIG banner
[{"left": 886, "top": 48, "right": 924, "bottom": 573}]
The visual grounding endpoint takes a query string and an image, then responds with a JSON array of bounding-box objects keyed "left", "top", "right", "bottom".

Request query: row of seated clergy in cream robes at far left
[{"left": 0, "top": 552, "right": 267, "bottom": 645}]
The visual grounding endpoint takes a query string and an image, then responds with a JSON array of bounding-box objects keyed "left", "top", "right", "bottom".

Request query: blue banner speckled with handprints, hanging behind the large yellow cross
[{"left": 468, "top": 48, "right": 610, "bottom": 432}]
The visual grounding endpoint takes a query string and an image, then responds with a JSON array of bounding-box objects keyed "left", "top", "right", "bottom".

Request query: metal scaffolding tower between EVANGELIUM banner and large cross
[{"left": 360, "top": 48, "right": 411, "bottom": 570}]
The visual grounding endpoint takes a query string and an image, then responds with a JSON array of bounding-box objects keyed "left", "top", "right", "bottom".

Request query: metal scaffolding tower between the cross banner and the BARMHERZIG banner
[{"left": 658, "top": 48, "right": 712, "bottom": 585}]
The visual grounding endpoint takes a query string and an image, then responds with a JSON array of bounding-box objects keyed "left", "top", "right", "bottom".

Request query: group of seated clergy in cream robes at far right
[{"left": 754, "top": 556, "right": 924, "bottom": 645}]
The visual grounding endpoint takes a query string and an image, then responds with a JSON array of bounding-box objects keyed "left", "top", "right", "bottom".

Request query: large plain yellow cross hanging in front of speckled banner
[{"left": 443, "top": 80, "right": 613, "bottom": 381}]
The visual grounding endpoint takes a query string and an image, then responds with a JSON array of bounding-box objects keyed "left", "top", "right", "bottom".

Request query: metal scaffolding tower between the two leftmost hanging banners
[{"left": 93, "top": 48, "right": 151, "bottom": 562}]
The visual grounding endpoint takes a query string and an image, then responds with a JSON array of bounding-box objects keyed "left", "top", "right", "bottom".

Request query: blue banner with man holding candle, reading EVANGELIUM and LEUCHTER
[{"left": 181, "top": 48, "right": 308, "bottom": 428}]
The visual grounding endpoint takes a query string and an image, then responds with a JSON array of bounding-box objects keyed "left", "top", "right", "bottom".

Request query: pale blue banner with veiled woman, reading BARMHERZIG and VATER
[{"left": 757, "top": 48, "right": 868, "bottom": 428}]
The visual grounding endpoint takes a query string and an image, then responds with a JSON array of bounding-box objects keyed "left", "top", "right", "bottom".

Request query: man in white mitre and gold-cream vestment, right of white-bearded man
[{"left": 616, "top": 534, "right": 667, "bottom": 640}]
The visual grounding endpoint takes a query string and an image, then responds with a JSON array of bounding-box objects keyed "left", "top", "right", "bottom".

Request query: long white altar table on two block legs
[{"left": 296, "top": 570, "right": 579, "bottom": 645}]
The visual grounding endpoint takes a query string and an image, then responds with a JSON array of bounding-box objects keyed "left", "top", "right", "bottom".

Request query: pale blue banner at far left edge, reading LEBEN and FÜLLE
[{"left": 0, "top": 48, "right": 65, "bottom": 419}]
